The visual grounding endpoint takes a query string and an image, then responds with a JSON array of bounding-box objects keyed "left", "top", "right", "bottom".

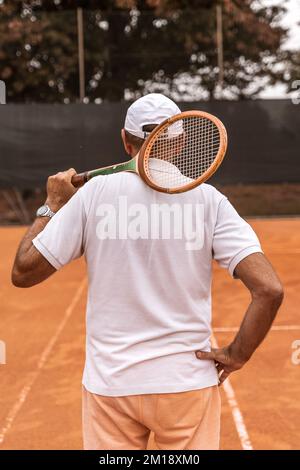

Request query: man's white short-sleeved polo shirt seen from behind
[{"left": 33, "top": 173, "right": 261, "bottom": 396}]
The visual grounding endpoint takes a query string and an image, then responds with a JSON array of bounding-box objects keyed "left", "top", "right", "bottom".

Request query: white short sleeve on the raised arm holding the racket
[{"left": 32, "top": 190, "right": 86, "bottom": 269}]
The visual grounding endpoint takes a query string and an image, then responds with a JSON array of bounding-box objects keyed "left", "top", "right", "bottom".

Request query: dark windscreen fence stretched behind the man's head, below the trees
[{"left": 0, "top": 100, "right": 300, "bottom": 189}]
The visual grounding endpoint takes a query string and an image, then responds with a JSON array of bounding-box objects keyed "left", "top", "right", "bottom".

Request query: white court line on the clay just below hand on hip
[{"left": 212, "top": 336, "right": 253, "bottom": 450}]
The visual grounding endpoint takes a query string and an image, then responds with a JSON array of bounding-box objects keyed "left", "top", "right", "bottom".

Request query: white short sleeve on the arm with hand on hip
[{"left": 213, "top": 198, "right": 262, "bottom": 276}]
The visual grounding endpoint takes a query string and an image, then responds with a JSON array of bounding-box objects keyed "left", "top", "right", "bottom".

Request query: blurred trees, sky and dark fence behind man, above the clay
[{"left": 0, "top": 0, "right": 300, "bottom": 224}]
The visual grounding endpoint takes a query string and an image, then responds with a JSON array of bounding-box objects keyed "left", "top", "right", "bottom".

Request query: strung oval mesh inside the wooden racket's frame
[{"left": 145, "top": 116, "right": 220, "bottom": 188}]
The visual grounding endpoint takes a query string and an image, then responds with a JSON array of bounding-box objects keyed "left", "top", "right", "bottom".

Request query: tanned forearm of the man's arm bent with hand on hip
[{"left": 230, "top": 291, "right": 283, "bottom": 362}]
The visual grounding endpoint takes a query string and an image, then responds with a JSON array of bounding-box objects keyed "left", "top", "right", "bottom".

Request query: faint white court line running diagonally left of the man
[{"left": 0, "top": 279, "right": 86, "bottom": 445}]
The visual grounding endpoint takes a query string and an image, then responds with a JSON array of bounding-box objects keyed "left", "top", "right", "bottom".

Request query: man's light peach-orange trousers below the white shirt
[{"left": 83, "top": 386, "right": 221, "bottom": 450}]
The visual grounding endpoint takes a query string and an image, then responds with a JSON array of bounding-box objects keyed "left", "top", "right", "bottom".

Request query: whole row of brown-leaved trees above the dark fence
[{"left": 0, "top": 0, "right": 291, "bottom": 102}]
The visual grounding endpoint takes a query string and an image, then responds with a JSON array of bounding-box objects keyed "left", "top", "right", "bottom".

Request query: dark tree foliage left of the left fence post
[{"left": 0, "top": 2, "right": 77, "bottom": 102}]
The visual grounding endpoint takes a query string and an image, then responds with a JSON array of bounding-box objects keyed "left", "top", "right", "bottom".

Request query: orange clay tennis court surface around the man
[{"left": 0, "top": 219, "right": 300, "bottom": 449}]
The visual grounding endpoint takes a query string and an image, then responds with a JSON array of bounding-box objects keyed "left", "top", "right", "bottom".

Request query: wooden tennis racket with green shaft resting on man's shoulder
[{"left": 72, "top": 111, "right": 227, "bottom": 194}]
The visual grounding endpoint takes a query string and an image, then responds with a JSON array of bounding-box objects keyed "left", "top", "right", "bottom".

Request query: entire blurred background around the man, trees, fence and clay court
[{"left": 0, "top": 0, "right": 300, "bottom": 449}]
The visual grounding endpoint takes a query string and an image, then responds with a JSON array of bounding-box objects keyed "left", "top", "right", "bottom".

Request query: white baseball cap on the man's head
[{"left": 124, "top": 93, "right": 181, "bottom": 139}]
